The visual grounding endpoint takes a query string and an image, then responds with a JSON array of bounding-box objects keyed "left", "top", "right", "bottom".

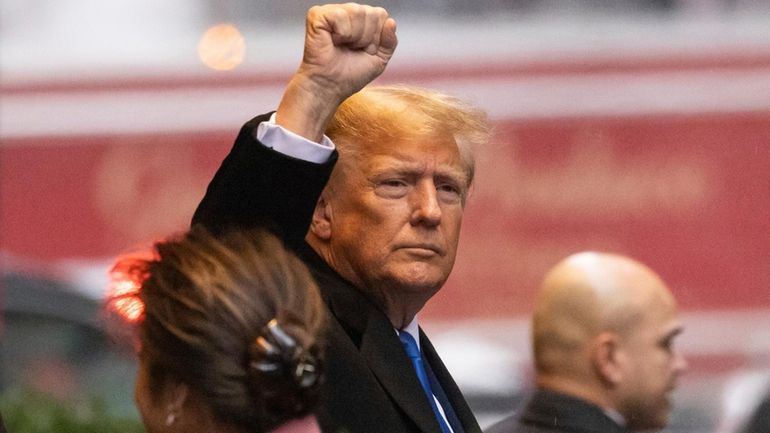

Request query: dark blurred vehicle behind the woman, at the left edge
[{"left": 0, "top": 272, "right": 138, "bottom": 420}]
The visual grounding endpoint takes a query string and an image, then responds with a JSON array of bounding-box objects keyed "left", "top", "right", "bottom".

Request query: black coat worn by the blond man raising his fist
[{"left": 193, "top": 115, "right": 481, "bottom": 433}]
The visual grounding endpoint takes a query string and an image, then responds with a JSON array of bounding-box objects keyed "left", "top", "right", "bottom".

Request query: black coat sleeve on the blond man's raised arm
[{"left": 192, "top": 113, "right": 337, "bottom": 248}]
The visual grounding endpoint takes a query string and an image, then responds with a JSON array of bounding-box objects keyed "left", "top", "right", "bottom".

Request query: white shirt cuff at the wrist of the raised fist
[{"left": 256, "top": 113, "right": 334, "bottom": 164}]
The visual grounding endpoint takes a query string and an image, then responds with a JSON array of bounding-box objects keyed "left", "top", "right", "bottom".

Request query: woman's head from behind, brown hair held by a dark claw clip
[{"left": 113, "top": 229, "right": 324, "bottom": 433}]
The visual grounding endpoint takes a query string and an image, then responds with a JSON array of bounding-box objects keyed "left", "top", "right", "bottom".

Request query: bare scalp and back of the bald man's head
[{"left": 533, "top": 252, "right": 673, "bottom": 372}]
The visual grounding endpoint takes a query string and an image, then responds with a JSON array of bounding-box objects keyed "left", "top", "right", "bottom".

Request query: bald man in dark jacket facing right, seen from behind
[{"left": 486, "top": 252, "right": 686, "bottom": 433}]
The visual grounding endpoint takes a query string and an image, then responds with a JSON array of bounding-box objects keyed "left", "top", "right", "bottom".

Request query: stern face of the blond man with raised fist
[{"left": 320, "top": 132, "right": 468, "bottom": 309}]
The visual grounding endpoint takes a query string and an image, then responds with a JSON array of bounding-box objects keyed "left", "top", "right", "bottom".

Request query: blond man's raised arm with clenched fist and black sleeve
[{"left": 192, "top": 3, "right": 397, "bottom": 245}]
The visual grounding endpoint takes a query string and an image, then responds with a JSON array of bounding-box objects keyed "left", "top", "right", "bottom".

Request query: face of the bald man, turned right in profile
[{"left": 618, "top": 296, "right": 687, "bottom": 430}]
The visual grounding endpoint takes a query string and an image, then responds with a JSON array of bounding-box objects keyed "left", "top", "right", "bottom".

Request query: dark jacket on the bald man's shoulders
[{"left": 484, "top": 390, "right": 629, "bottom": 433}]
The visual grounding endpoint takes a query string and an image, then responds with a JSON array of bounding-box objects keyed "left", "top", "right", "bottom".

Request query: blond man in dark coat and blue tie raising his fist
[{"left": 193, "top": 3, "right": 488, "bottom": 433}]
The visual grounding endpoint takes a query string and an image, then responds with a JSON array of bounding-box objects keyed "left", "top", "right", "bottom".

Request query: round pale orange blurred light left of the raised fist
[{"left": 198, "top": 24, "right": 246, "bottom": 71}]
